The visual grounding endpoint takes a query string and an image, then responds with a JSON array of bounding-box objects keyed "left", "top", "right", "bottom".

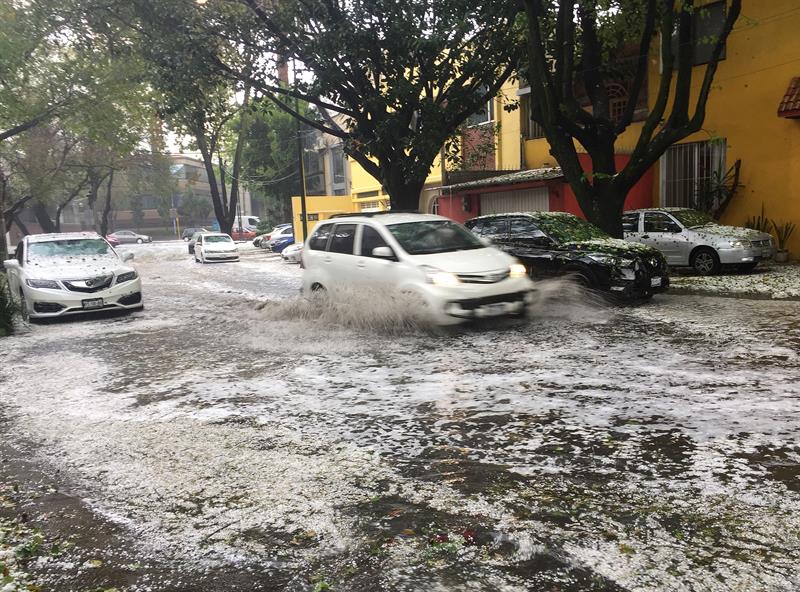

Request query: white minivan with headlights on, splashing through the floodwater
[{"left": 302, "top": 212, "right": 533, "bottom": 324}]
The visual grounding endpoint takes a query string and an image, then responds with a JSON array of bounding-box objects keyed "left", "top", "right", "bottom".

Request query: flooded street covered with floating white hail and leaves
[{"left": 0, "top": 244, "right": 800, "bottom": 592}]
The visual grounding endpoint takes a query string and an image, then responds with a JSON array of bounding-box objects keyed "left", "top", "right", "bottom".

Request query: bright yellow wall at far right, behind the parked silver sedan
[{"left": 650, "top": 0, "right": 800, "bottom": 257}]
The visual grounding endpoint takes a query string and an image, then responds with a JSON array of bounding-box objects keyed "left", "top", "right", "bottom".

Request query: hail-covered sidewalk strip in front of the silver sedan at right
[{"left": 669, "top": 262, "right": 800, "bottom": 300}]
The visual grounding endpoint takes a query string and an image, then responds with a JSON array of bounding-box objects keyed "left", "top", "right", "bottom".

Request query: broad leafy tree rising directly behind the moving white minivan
[{"left": 171, "top": 0, "right": 521, "bottom": 209}]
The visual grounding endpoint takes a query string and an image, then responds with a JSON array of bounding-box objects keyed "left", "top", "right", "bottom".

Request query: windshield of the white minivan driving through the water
[{"left": 386, "top": 220, "right": 486, "bottom": 255}]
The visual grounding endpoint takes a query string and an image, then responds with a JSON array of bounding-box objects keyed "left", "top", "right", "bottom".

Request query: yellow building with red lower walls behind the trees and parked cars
[{"left": 295, "top": 0, "right": 800, "bottom": 257}]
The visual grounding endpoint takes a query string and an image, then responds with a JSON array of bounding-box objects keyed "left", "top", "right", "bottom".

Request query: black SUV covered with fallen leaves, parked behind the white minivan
[{"left": 464, "top": 212, "right": 669, "bottom": 300}]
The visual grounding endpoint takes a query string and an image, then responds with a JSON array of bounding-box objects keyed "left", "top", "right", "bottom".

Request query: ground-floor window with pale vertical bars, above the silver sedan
[{"left": 661, "top": 140, "right": 726, "bottom": 208}]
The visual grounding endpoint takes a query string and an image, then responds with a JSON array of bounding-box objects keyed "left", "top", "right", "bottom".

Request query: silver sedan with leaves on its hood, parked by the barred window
[{"left": 622, "top": 208, "right": 773, "bottom": 275}]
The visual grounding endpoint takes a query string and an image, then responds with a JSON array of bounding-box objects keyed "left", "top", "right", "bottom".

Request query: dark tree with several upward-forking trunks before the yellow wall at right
[{"left": 524, "top": 0, "right": 741, "bottom": 237}]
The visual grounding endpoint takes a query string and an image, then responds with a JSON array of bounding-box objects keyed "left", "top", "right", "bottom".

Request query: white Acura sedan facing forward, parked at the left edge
[{"left": 3, "top": 232, "right": 142, "bottom": 319}]
